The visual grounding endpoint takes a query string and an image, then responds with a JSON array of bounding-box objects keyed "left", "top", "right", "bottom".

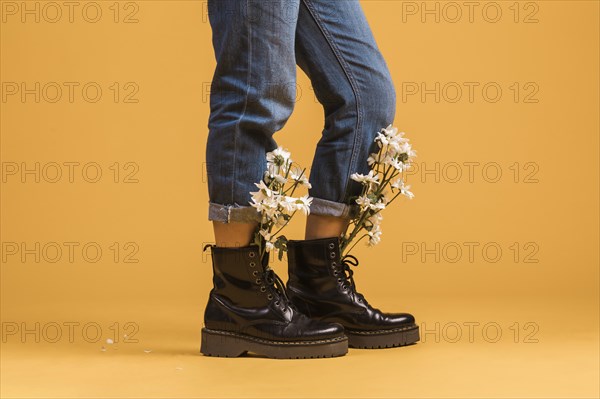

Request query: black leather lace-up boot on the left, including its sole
[{"left": 200, "top": 245, "right": 348, "bottom": 358}]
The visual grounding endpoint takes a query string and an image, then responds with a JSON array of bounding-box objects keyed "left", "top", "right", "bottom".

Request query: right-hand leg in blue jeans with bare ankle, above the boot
[{"left": 296, "top": 0, "right": 396, "bottom": 234}]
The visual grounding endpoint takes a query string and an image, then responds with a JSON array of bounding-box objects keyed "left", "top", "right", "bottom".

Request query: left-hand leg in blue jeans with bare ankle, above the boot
[{"left": 206, "top": 0, "right": 300, "bottom": 246}]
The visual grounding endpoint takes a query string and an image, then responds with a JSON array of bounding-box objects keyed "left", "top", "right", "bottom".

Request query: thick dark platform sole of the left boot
[{"left": 200, "top": 328, "right": 348, "bottom": 359}]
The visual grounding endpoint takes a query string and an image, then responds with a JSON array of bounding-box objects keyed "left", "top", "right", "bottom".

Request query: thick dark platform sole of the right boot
[{"left": 345, "top": 325, "right": 420, "bottom": 349}]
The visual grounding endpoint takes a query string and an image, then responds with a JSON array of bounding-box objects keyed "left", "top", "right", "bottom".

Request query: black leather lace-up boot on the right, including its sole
[{"left": 287, "top": 237, "right": 419, "bottom": 348}]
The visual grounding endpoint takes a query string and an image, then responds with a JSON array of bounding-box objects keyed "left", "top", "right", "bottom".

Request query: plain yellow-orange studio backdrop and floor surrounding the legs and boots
[{"left": 0, "top": 0, "right": 600, "bottom": 397}]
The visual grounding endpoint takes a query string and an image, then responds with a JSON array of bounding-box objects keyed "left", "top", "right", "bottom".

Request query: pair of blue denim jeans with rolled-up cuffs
[{"left": 206, "top": 0, "right": 396, "bottom": 223}]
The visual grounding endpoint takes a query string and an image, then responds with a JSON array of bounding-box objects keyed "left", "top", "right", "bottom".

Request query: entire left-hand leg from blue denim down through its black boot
[{"left": 201, "top": 0, "right": 348, "bottom": 359}]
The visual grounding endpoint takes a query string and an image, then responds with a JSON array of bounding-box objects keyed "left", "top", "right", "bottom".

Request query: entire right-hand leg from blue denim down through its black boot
[{"left": 287, "top": 0, "right": 419, "bottom": 348}]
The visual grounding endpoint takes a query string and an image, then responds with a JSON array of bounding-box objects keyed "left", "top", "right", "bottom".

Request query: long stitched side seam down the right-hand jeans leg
[{"left": 302, "top": 0, "right": 363, "bottom": 202}]
